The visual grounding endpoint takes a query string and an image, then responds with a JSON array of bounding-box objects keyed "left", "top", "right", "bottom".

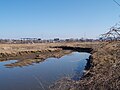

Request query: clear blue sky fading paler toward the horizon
[{"left": 0, "top": 0, "right": 120, "bottom": 39}]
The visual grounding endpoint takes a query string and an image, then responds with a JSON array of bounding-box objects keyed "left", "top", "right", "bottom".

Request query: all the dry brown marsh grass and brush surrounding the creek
[{"left": 0, "top": 41, "right": 120, "bottom": 90}]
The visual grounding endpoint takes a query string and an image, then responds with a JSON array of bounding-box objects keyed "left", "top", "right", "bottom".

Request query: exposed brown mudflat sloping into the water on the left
[{"left": 2, "top": 49, "right": 72, "bottom": 67}]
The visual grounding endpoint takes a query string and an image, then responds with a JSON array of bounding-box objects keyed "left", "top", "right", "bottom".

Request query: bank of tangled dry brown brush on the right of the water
[{"left": 51, "top": 41, "right": 120, "bottom": 90}]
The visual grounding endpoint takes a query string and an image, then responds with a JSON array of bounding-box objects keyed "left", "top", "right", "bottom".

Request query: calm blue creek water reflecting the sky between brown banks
[{"left": 0, "top": 52, "right": 90, "bottom": 90}]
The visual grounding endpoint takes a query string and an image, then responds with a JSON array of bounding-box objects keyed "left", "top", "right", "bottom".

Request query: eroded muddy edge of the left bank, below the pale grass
[{"left": 0, "top": 48, "right": 73, "bottom": 68}]
